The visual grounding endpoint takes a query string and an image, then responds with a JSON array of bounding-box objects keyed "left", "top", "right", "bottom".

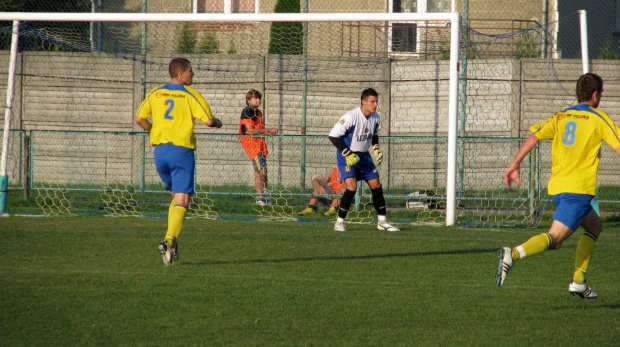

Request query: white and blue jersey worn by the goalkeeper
[{"left": 329, "top": 107, "right": 381, "bottom": 153}]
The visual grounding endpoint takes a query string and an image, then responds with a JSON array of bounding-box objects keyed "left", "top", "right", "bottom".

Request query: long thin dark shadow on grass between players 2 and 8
[{"left": 180, "top": 248, "right": 497, "bottom": 266}]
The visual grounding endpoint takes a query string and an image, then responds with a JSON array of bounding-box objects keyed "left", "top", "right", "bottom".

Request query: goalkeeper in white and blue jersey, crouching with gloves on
[{"left": 329, "top": 88, "right": 399, "bottom": 231}]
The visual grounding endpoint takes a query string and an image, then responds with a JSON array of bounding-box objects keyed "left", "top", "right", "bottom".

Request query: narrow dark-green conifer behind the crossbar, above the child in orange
[{"left": 268, "top": 0, "right": 303, "bottom": 55}]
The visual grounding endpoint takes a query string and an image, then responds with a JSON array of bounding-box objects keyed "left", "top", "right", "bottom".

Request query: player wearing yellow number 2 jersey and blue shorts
[{"left": 136, "top": 58, "right": 222, "bottom": 265}]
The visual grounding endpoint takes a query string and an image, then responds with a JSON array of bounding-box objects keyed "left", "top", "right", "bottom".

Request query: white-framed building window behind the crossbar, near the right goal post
[{"left": 389, "top": 0, "right": 452, "bottom": 53}]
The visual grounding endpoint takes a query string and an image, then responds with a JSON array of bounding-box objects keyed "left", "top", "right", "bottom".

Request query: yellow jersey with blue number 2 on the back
[{"left": 137, "top": 83, "right": 215, "bottom": 149}]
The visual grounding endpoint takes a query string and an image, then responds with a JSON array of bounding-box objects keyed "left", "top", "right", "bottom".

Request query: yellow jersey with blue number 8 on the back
[{"left": 530, "top": 103, "right": 620, "bottom": 195}]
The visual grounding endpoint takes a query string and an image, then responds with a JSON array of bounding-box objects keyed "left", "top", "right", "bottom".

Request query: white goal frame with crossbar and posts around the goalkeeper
[{"left": 0, "top": 12, "right": 461, "bottom": 226}]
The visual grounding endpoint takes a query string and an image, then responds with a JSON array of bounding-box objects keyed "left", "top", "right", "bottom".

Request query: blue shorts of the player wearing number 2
[{"left": 155, "top": 143, "right": 196, "bottom": 194}]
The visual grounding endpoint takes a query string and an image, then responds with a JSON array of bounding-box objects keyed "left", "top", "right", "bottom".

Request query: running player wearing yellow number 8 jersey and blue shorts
[{"left": 495, "top": 73, "right": 620, "bottom": 299}]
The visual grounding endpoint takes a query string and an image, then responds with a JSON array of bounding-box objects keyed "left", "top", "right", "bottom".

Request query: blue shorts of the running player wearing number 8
[{"left": 551, "top": 193, "right": 594, "bottom": 231}]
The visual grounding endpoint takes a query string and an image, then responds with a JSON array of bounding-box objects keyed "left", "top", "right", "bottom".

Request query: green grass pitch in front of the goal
[{"left": 0, "top": 217, "right": 620, "bottom": 346}]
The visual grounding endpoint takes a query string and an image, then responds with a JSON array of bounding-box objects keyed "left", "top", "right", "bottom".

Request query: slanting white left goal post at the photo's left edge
[{"left": 0, "top": 21, "right": 19, "bottom": 216}]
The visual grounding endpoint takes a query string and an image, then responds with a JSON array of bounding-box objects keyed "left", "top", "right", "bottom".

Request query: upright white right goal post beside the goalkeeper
[{"left": 446, "top": 12, "right": 461, "bottom": 226}]
